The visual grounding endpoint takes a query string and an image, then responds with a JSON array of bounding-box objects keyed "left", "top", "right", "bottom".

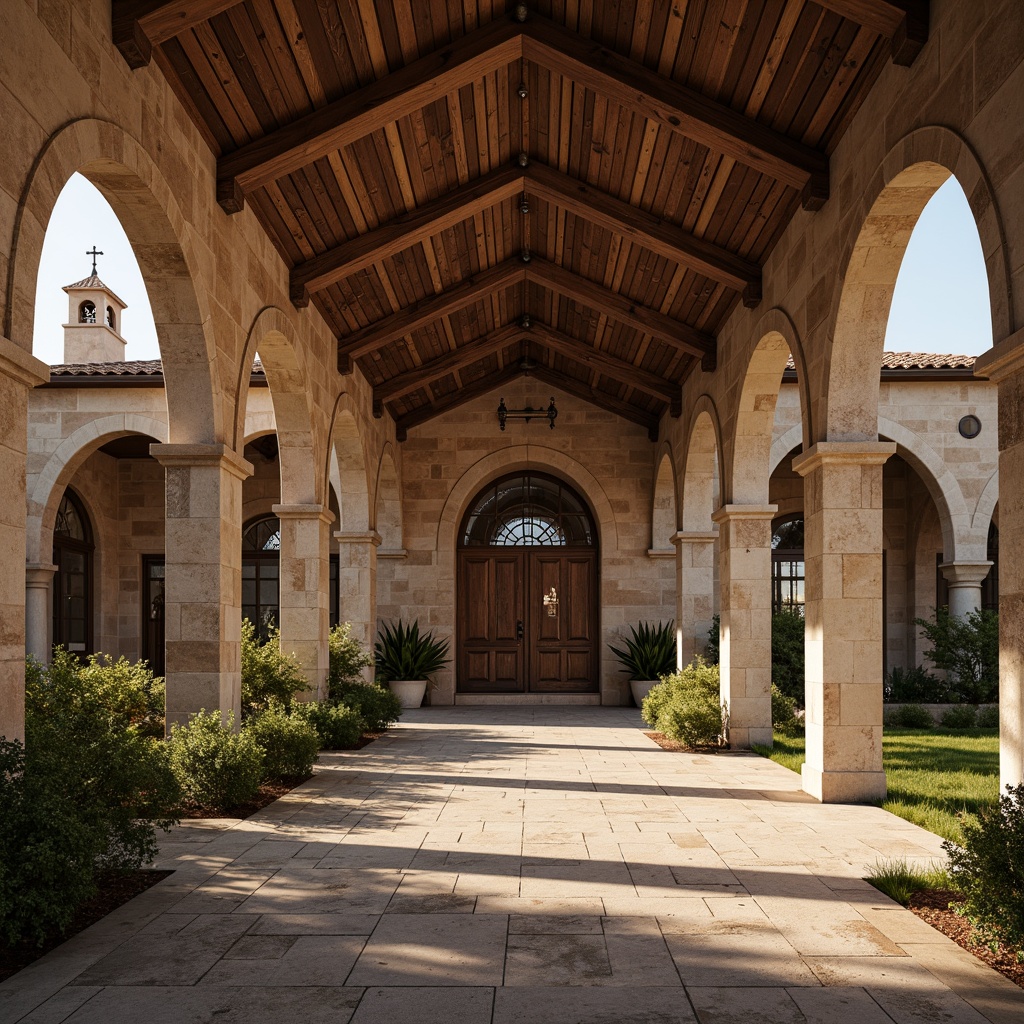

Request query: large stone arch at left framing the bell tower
[{"left": 3, "top": 118, "right": 221, "bottom": 443}]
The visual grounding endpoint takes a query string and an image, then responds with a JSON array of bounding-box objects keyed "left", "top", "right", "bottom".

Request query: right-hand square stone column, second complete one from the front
[{"left": 712, "top": 505, "right": 778, "bottom": 750}]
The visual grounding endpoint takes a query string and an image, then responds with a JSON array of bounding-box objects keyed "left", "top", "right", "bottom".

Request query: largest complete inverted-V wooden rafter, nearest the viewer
[{"left": 217, "top": 14, "right": 828, "bottom": 213}]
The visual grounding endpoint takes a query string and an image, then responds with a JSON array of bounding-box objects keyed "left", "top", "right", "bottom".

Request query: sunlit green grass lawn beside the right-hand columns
[{"left": 755, "top": 728, "right": 999, "bottom": 842}]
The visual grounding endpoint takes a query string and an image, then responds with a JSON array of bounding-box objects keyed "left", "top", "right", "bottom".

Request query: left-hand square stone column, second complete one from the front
[{"left": 273, "top": 505, "right": 334, "bottom": 699}]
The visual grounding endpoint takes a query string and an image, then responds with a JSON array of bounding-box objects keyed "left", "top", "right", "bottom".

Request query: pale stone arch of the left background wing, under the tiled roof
[{"left": 26, "top": 413, "right": 167, "bottom": 562}]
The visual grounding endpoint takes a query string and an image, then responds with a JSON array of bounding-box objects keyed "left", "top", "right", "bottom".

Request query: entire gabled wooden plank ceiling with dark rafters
[{"left": 112, "top": 0, "right": 928, "bottom": 437}]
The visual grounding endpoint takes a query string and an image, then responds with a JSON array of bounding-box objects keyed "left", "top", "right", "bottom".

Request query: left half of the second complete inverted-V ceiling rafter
[{"left": 292, "top": 168, "right": 523, "bottom": 306}]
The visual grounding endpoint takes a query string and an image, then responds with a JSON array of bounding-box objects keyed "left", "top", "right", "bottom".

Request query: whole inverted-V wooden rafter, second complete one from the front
[{"left": 292, "top": 163, "right": 761, "bottom": 306}]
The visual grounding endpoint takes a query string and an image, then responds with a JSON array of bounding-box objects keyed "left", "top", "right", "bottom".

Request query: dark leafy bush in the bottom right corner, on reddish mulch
[{"left": 942, "top": 785, "right": 1024, "bottom": 946}]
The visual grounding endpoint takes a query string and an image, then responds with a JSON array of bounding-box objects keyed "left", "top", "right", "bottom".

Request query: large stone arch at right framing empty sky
[{"left": 814, "top": 126, "right": 1014, "bottom": 441}]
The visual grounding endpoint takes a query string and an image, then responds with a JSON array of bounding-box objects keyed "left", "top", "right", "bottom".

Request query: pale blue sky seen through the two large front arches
[{"left": 33, "top": 174, "right": 992, "bottom": 364}]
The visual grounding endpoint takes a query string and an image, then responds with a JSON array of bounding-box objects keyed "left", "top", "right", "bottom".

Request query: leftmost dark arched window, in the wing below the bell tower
[{"left": 53, "top": 488, "right": 93, "bottom": 654}]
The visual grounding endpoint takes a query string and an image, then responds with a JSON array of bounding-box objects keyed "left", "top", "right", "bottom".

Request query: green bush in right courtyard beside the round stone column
[{"left": 914, "top": 608, "right": 999, "bottom": 705}]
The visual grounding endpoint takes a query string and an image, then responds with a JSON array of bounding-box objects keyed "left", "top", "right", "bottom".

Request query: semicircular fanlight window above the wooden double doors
[{"left": 460, "top": 473, "right": 596, "bottom": 548}]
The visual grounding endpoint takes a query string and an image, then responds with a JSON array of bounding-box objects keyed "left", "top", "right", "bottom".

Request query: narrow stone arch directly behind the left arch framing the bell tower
[{"left": 234, "top": 306, "right": 326, "bottom": 505}]
